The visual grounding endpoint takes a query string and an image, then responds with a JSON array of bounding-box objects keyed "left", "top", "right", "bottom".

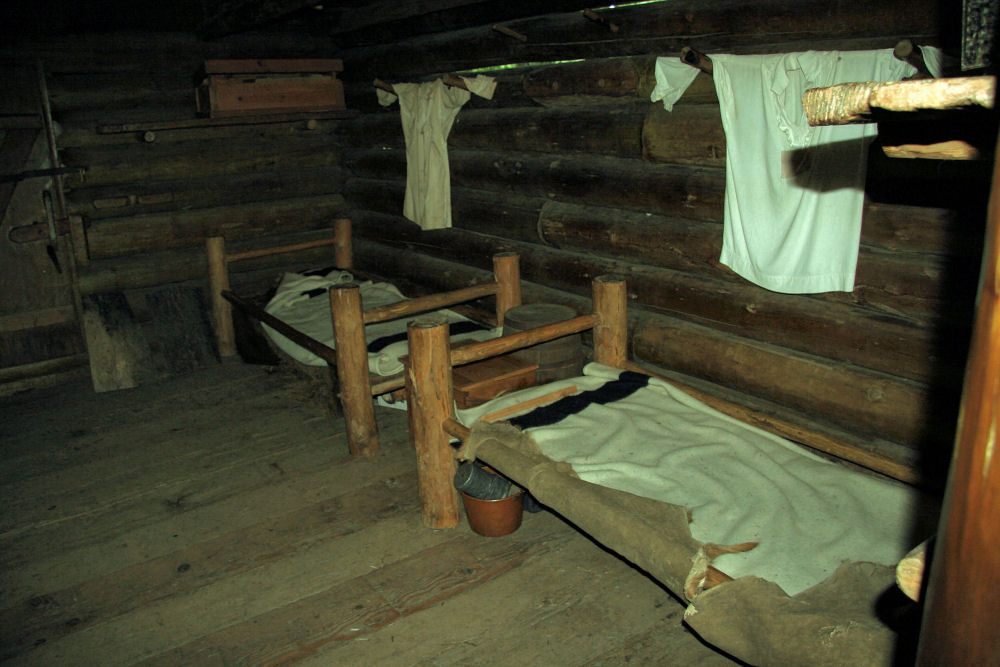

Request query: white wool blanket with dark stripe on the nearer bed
[{"left": 459, "top": 364, "right": 937, "bottom": 595}]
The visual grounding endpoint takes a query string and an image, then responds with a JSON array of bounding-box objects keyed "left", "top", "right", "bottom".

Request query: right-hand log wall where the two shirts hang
[{"left": 330, "top": 0, "right": 988, "bottom": 482}]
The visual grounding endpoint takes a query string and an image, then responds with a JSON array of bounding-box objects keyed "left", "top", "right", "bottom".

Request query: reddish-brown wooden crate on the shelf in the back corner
[{"left": 195, "top": 59, "right": 344, "bottom": 118}]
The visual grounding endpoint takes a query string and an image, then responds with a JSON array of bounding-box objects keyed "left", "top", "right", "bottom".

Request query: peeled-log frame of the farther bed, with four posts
[{"left": 206, "top": 218, "right": 521, "bottom": 456}]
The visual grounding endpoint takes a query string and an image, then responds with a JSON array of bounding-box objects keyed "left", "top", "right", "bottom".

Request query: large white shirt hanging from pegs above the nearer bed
[{"left": 711, "top": 49, "right": 915, "bottom": 294}]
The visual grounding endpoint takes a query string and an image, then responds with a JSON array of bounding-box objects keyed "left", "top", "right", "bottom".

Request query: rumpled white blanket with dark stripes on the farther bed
[{"left": 263, "top": 269, "right": 502, "bottom": 375}]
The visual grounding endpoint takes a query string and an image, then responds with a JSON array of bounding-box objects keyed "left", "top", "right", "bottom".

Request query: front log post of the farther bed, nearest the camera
[{"left": 330, "top": 283, "right": 378, "bottom": 456}]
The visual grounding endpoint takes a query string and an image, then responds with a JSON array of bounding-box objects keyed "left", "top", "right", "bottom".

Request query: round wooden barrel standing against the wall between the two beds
[{"left": 503, "top": 303, "right": 583, "bottom": 384}]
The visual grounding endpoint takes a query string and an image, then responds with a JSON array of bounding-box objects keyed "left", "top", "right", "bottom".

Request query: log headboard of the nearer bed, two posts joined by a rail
[{"left": 406, "top": 276, "right": 628, "bottom": 529}]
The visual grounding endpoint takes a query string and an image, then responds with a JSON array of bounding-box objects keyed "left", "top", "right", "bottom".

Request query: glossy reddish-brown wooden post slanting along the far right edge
[{"left": 917, "top": 130, "right": 1000, "bottom": 665}]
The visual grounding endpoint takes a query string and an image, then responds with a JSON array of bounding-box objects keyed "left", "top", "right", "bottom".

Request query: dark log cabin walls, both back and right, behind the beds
[{"left": 0, "top": 0, "right": 989, "bottom": 490}]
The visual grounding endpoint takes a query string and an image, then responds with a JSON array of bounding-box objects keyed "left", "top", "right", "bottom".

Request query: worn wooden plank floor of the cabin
[{"left": 0, "top": 362, "right": 744, "bottom": 667}]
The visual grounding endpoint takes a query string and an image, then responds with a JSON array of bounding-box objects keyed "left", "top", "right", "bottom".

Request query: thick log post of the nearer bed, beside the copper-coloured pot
[{"left": 406, "top": 318, "right": 459, "bottom": 528}]
